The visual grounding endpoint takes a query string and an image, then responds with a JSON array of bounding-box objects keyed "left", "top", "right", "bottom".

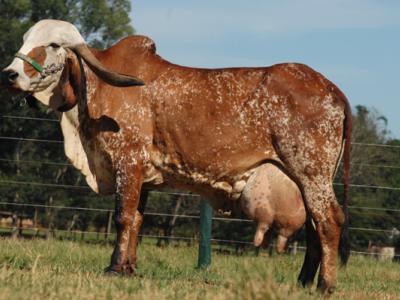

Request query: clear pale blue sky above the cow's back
[{"left": 131, "top": 0, "right": 400, "bottom": 138}]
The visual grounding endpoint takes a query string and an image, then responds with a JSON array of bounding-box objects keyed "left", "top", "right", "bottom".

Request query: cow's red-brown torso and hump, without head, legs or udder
[{"left": 82, "top": 37, "right": 345, "bottom": 195}]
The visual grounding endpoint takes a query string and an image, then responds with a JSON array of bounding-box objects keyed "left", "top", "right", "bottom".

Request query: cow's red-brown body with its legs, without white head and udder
[{"left": 66, "top": 36, "right": 351, "bottom": 289}]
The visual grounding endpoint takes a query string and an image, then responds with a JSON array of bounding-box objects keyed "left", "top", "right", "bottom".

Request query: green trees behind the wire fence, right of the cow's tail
[{"left": 335, "top": 105, "right": 400, "bottom": 250}]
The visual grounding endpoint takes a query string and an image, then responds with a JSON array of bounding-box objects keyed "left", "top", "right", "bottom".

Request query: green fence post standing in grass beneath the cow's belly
[{"left": 197, "top": 199, "right": 213, "bottom": 268}]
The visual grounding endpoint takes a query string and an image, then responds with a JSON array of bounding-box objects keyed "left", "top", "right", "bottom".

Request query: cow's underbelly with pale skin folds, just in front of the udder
[{"left": 145, "top": 145, "right": 279, "bottom": 212}]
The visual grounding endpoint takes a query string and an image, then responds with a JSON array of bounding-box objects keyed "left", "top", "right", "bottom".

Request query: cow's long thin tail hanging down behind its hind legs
[{"left": 339, "top": 92, "right": 352, "bottom": 266}]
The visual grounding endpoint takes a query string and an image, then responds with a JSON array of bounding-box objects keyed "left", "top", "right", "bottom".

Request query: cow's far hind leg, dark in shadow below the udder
[{"left": 298, "top": 217, "right": 321, "bottom": 287}]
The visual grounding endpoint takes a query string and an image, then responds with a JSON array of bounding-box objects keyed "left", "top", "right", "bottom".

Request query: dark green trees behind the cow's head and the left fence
[{"left": 0, "top": 0, "right": 134, "bottom": 237}]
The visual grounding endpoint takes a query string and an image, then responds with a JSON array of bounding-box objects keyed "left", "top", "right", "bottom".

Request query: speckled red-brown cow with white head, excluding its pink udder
[{"left": 1, "top": 20, "right": 351, "bottom": 292}]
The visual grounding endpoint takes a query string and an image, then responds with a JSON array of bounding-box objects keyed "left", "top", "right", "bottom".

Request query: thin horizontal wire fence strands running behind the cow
[{"left": 0, "top": 115, "right": 400, "bottom": 256}]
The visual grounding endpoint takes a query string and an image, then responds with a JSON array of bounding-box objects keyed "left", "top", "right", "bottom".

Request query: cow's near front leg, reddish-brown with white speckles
[{"left": 106, "top": 162, "right": 142, "bottom": 274}]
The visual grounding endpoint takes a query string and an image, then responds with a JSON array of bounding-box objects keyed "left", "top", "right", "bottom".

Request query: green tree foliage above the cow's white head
[{"left": 0, "top": 0, "right": 134, "bottom": 61}]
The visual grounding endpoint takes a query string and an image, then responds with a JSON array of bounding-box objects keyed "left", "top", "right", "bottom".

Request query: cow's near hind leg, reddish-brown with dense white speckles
[{"left": 276, "top": 132, "right": 344, "bottom": 292}]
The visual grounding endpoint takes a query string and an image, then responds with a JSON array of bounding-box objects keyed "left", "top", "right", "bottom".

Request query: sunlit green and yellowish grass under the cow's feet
[{"left": 0, "top": 239, "right": 400, "bottom": 299}]
